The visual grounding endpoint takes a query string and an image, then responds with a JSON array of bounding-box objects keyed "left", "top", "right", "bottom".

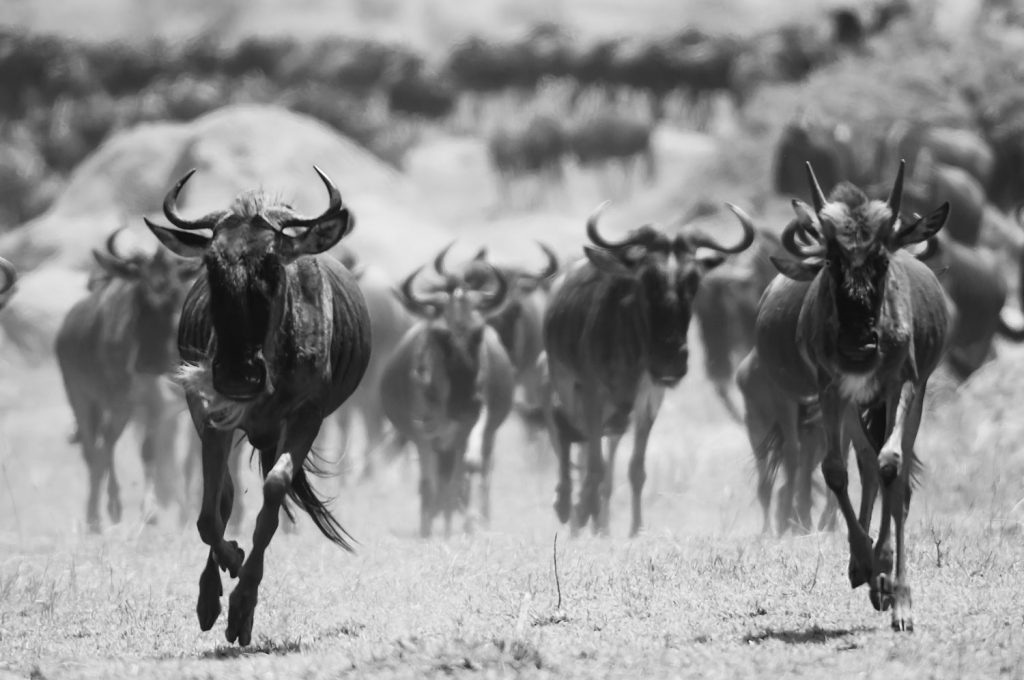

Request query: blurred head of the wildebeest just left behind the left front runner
[{"left": 90, "top": 225, "right": 199, "bottom": 375}]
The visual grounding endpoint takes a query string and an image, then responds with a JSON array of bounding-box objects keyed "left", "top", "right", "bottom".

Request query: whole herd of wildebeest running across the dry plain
[{"left": 9, "top": 9, "right": 1024, "bottom": 645}]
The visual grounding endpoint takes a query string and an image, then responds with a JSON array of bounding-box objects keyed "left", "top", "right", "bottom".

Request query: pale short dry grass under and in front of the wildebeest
[{"left": 6, "top": 340, "right": 1024, "bottom": 678}]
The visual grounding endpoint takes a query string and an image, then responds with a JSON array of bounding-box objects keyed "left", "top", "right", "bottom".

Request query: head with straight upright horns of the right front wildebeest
[{"left": 772, "top": 162, "right": 949, "bottom": 373}]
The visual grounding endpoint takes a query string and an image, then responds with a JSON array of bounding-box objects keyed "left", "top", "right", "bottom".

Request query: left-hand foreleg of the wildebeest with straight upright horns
[{"left": 821, "top": 386, "right": 871, "bottom": 588}]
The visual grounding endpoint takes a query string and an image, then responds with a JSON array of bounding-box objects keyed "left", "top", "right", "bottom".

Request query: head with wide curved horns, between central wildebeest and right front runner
[{"left": 584, "top": 200, "right": 754, "bottom": 385}]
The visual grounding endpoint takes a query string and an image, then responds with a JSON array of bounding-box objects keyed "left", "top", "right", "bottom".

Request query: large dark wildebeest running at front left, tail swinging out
[{"left": 146, "top": 168, "right": 371, "bottom": 645}]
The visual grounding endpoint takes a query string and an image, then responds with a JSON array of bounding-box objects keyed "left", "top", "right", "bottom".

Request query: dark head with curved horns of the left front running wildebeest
[{"left": 146, "top": 166, "right": 354, "bottom": 401}]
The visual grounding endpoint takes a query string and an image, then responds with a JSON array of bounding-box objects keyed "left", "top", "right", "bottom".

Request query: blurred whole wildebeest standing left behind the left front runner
[{"left": 55, "top": 227, "right": 197, "bottom": 532}]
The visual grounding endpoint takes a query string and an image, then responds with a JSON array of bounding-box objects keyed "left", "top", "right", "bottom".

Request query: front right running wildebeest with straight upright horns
[{"left": 755, "top": 163, "right": 949, "bottom": 630}]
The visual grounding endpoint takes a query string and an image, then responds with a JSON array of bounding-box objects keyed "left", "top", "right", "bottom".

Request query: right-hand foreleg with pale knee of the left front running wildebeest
[{"left": 224, "top": 414, "right": 321, "bottom": 646}]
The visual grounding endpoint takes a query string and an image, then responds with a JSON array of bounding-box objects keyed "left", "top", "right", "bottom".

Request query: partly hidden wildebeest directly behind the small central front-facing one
[{"left": 454, "top": 242, "right": 559, "bottom": 423}]
